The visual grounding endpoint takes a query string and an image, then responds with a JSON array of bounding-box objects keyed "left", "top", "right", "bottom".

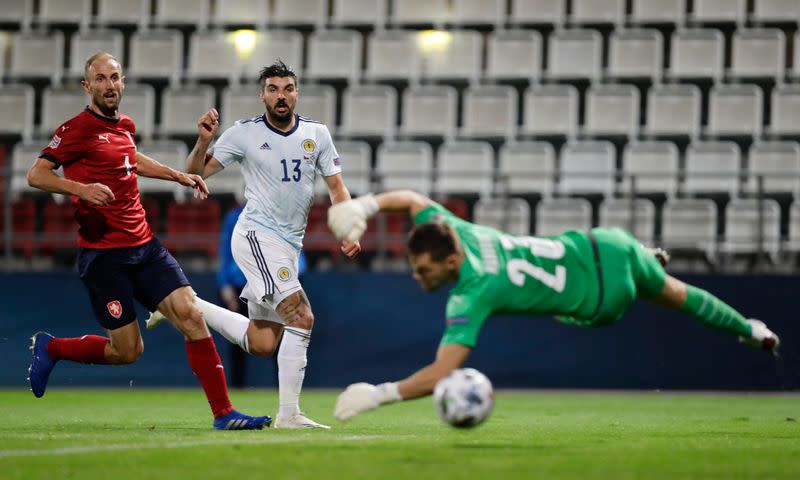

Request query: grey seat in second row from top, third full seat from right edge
[{"left": 608, "top": 29, "right": 664, "bottom": 82}]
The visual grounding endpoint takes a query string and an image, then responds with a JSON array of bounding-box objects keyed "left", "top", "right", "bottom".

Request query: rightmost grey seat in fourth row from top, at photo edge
[{"left": 747, "top": 141, "right": 800, "bottom": 198}]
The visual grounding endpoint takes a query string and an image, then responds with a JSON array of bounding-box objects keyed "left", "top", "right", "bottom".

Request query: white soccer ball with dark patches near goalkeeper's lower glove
[{"left": 433, "top": 368, "right": 494, "bottom": 428}]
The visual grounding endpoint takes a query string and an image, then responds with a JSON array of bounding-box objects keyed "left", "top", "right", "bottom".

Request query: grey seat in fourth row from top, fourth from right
[{"left": 558, "top": 141, "right": 616, "bottom": 197}]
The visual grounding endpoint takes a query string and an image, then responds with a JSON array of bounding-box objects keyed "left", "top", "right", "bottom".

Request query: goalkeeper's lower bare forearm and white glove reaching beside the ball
[{"left": 333, "top": 344, "right": 472, "bottom": 421}]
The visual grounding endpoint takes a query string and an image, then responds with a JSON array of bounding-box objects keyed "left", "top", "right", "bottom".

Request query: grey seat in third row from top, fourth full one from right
[{"left": 520, "top": 85, "right": 579, "bottom": 139}]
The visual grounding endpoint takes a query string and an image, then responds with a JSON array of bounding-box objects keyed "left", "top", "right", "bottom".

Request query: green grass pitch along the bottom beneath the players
[{"left": 0, "top": 389, "right": 800, "bottom": 480}]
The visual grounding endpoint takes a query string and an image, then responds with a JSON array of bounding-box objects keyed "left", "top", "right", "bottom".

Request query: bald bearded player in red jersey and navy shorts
[{"left": 28, "top": 52, "right": 272, "bottom": 430}]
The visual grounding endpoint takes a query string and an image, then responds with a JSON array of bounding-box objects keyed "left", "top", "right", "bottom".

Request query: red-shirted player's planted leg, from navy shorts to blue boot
[{"left": 135, "top": 240, "right": 272, "bottom": 430}]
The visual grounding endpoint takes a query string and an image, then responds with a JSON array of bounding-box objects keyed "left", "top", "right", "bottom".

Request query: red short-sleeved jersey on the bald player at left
[{"left": 39, "top": 107, "right": 153, "bottom": 248}]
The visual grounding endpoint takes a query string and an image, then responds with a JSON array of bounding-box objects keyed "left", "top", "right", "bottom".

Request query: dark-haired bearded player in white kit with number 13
[{"left": 148, "top": 61, "right": 361, "bottom": 428}]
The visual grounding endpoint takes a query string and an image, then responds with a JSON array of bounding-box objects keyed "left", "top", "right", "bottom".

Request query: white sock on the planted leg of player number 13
[{"left": 278, "top": 327, "right": 311, "bottom": 417}]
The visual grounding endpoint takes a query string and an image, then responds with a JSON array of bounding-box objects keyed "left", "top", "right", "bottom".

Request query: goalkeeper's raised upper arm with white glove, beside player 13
[{"left": 328, "top": 190, "right": 433, "bottom": 241}]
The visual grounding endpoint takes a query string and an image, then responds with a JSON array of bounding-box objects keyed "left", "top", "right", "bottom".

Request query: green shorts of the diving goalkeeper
[{"left": 559, "top": 228, "right": 666, "bottom": 327}]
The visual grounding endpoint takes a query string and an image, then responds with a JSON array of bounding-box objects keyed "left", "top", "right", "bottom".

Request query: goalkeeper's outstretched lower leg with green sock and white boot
[{"left": 645, "top": 275, "right": 780, "bottom": 351}]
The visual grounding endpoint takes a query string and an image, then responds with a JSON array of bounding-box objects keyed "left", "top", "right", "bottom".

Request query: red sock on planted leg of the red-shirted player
[{"left": 186, "top": 337, "right": 233, "bottom": 418}]
